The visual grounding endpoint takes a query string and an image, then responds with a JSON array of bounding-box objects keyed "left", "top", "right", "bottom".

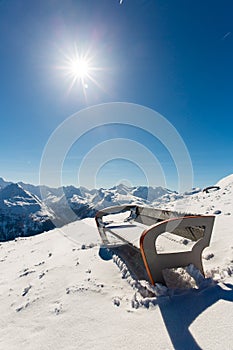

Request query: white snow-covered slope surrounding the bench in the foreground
[{"left": 0, "top": 176, "right": 233, "bottom": 350}]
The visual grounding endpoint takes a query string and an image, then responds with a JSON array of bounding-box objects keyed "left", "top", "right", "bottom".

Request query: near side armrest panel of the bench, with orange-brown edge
[{"left": 140, "top": 215, "right": 215, "bottom": 284}]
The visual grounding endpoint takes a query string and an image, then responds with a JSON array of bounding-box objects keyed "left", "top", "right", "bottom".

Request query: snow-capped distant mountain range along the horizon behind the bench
[{"left": 0, "top": 178, "right": 208, "bottom": 241}]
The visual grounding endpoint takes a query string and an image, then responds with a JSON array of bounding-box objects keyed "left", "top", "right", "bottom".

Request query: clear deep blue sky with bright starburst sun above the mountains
[{"left": 0, "top": 0, "right": 233, "bottom": 189}]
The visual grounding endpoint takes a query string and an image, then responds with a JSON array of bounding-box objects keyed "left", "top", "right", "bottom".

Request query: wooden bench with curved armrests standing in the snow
[{"left": 95, "top": 205, "right": 215, "bottom": 285}]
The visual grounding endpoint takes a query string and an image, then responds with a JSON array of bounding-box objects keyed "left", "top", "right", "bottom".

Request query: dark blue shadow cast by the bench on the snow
[{"left": 99, "top": 246, "right": 233, "bottom": 350}]
